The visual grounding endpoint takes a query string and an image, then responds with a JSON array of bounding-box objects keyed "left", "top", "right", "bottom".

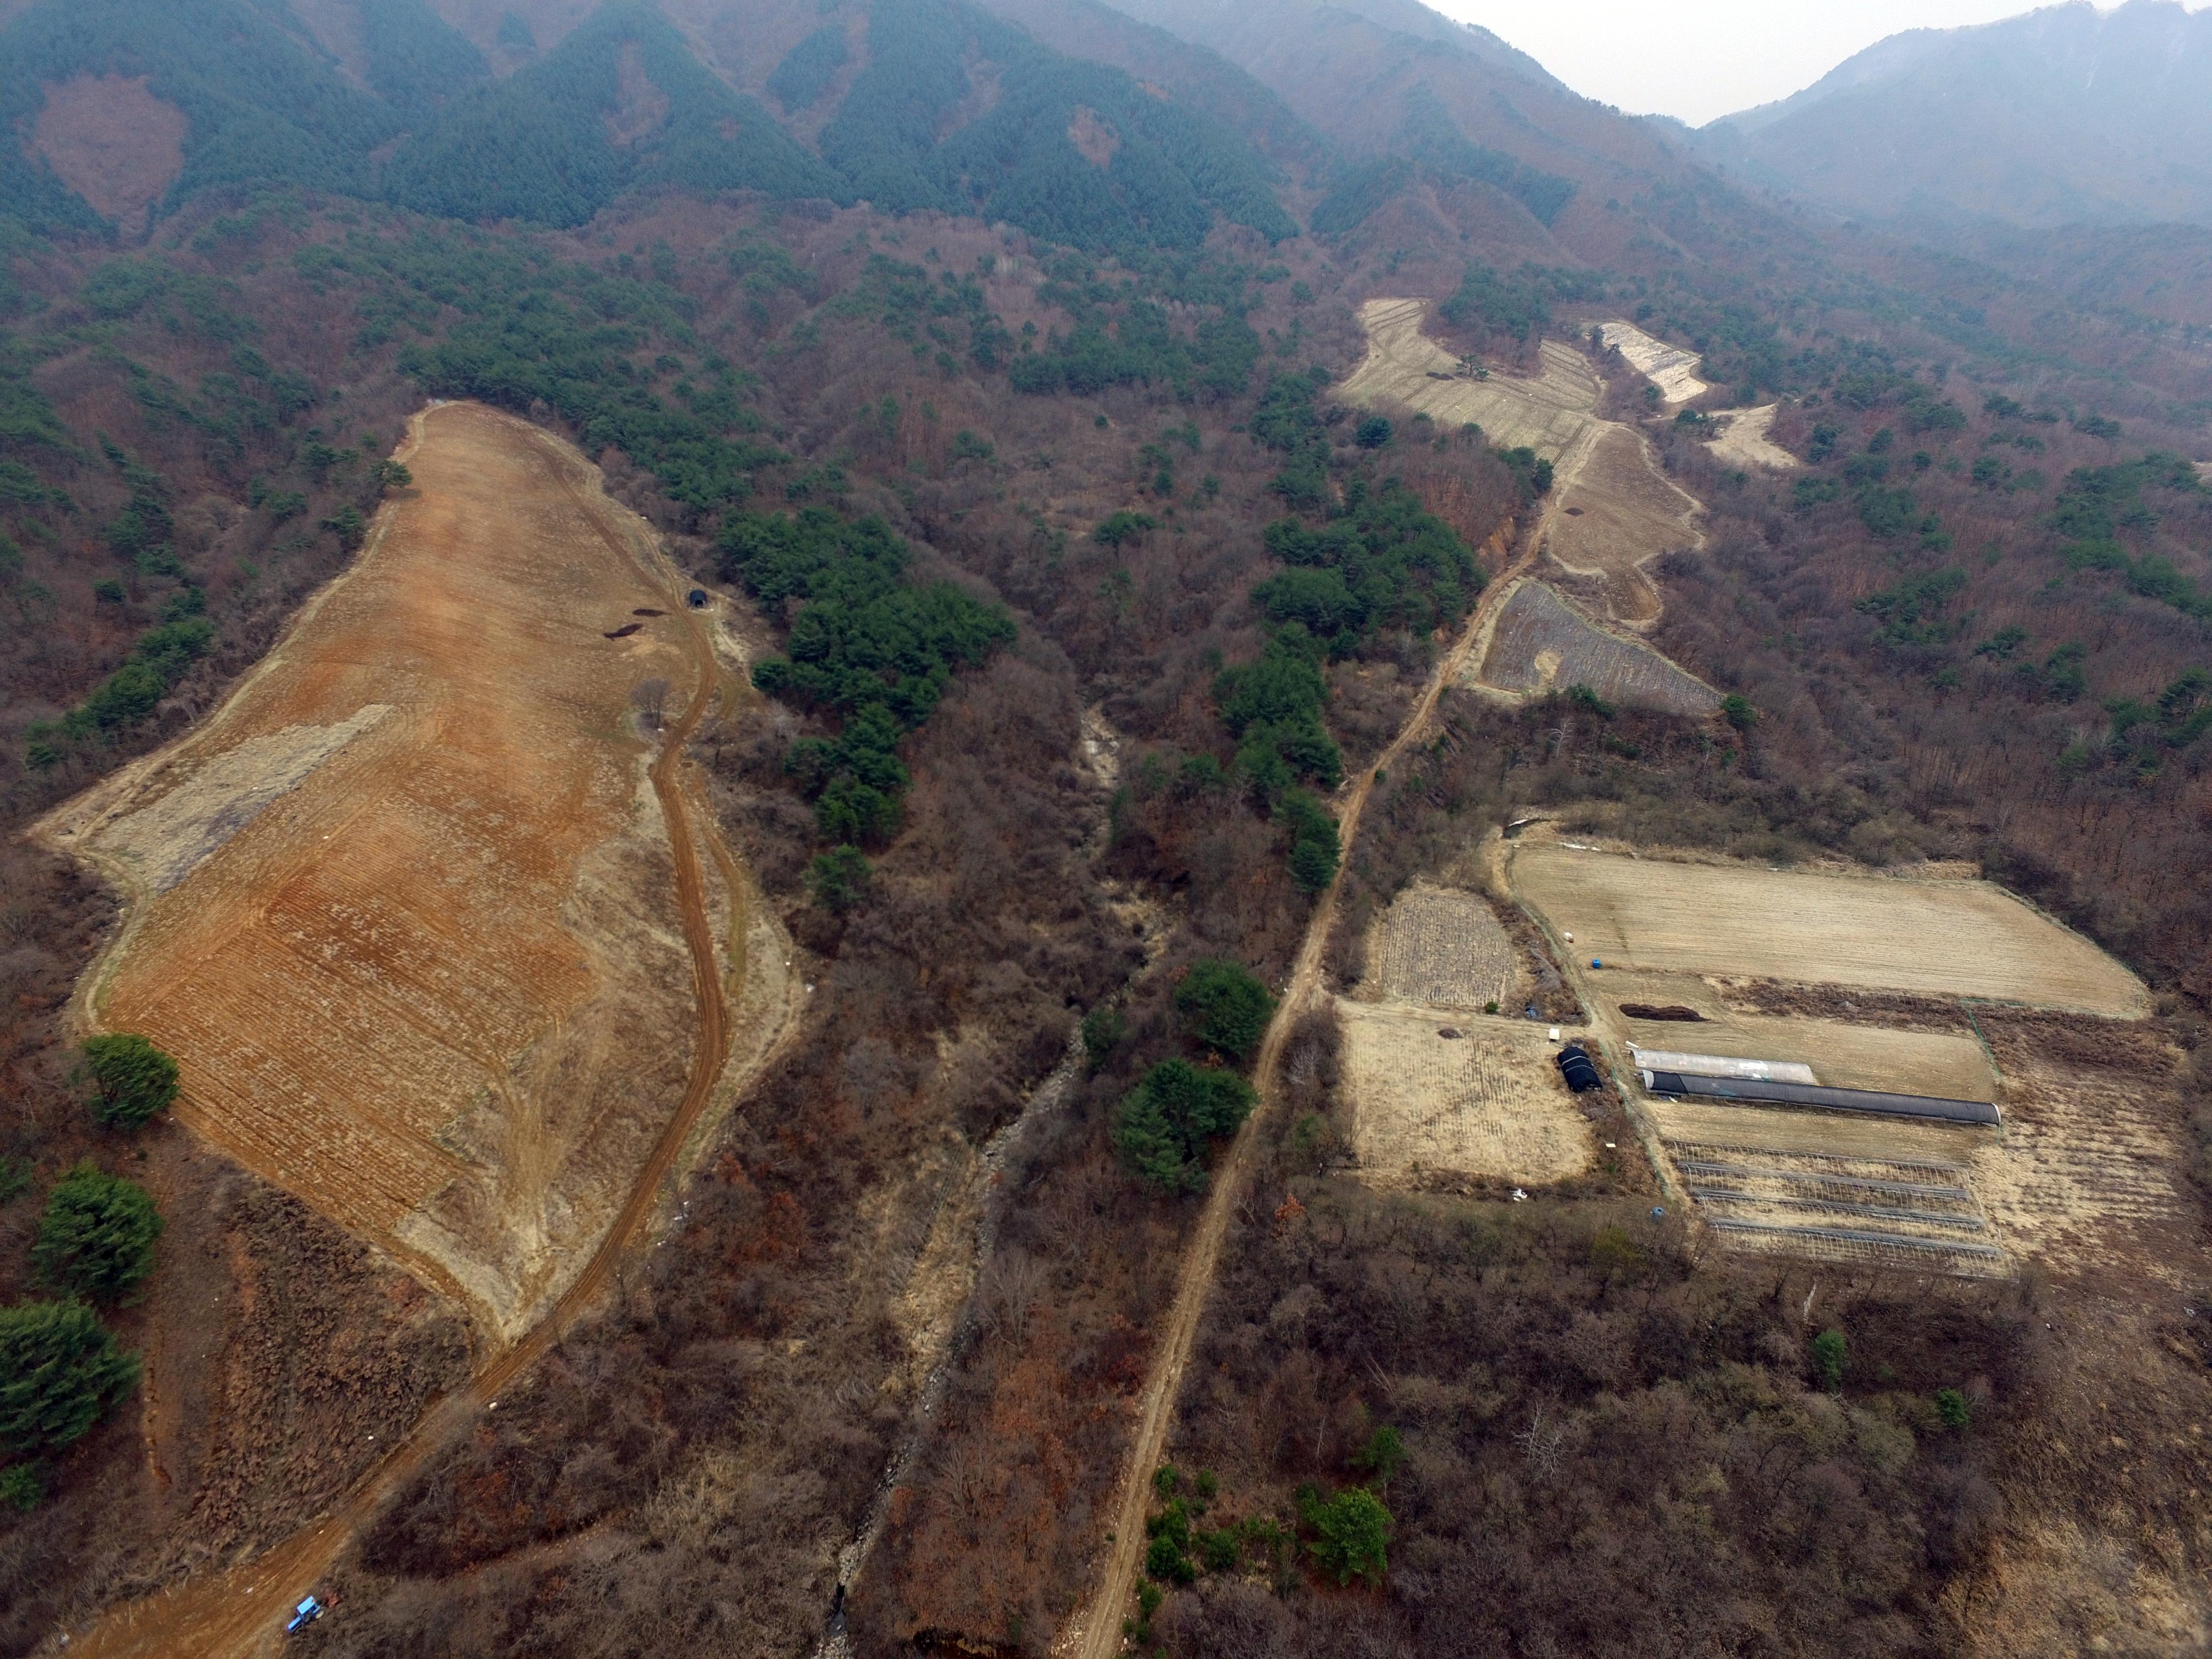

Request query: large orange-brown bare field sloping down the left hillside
[{"left": 44, "top": 405, "right": 734, "bottom": 1336}]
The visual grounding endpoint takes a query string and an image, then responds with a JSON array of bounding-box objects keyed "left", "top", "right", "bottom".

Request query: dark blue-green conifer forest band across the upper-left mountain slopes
[{"left": 0, "top": 0, "right": 1298, "bottom": 252}]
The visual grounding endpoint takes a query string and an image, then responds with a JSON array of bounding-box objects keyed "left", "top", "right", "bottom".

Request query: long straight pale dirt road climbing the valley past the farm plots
[{"left": 1055, "top": 434, "right": 1593, "bottom": 1659}]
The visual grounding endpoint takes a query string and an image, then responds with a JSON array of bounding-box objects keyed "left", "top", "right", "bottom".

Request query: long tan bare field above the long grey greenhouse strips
[{"left": 1513, "top": 845, "right": 2148, "bottom": 1018}]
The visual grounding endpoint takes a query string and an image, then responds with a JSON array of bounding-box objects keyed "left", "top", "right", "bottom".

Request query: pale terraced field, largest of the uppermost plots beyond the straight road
[{"left": 1343, "top": 299, "right": 1599, "bottom": 462}]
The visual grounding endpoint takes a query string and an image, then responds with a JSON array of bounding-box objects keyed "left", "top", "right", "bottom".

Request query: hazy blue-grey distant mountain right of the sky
[{"left": 1697, "top": 0, "right": 2212, "bottom": 226}]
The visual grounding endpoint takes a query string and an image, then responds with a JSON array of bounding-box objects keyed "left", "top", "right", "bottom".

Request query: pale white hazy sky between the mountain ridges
[{"left": 1429, "top": 0, "right": 2132, "bottom": 126}]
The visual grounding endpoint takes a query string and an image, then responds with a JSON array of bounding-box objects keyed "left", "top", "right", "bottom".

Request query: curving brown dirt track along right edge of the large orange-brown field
[{"left": 71, "top": 405, "right": 799, "bottom": 1659}]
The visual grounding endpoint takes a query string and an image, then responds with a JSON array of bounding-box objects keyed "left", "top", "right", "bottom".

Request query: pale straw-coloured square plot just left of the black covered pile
[{"left": 1338, "top": 1000, "right": 1593, "bottom": 1186}]
